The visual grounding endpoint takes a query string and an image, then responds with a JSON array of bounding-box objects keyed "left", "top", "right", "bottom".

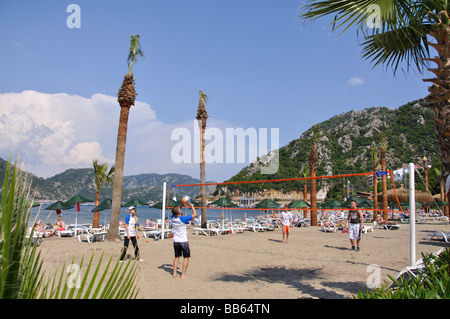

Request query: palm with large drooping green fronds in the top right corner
[{"left": 302, "top": 0, "right": 450, "bottom": 192}]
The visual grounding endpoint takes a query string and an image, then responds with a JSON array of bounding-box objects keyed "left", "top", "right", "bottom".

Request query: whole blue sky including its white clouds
[{"left": 0, "top": 0, "right": 428, "bottom": 182}]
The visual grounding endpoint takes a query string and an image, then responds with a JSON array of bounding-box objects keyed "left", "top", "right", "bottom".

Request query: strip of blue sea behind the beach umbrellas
[{"left": 28, "top": 204, "right": 265, "bottom": 227}]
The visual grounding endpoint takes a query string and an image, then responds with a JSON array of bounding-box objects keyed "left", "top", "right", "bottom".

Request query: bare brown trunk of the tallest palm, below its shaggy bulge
[{"left": 108, "top": 106, "right": 130, "bottom": 241}]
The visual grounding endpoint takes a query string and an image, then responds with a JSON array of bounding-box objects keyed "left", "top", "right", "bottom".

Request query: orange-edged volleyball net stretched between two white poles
[{"left": 163, "top": 170, "right": 402, "bottom": 218}]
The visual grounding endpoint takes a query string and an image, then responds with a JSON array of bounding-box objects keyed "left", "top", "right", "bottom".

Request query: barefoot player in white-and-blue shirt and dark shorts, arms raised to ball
[{"left": 172, "top": 202, "right": 197, "bottom": 278}]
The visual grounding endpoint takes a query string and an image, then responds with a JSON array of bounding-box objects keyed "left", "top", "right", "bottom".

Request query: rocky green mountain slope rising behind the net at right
[{"left": 220, "top": 101, "right": 440, "bottom": 197}]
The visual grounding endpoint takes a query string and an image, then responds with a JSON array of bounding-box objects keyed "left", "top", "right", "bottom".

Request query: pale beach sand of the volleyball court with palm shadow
[{"left": 39, "top": 221, "right": 450, "bottom": 299}]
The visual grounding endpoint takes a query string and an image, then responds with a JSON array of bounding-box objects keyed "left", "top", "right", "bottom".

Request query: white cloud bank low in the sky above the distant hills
[{"left": 0, "top": 90, "right": 252, "bottom": 181}]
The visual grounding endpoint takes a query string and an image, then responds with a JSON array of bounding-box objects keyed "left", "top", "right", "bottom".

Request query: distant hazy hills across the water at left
[{"left": 0, "top": 158, "right": 215, "bottom": 202}]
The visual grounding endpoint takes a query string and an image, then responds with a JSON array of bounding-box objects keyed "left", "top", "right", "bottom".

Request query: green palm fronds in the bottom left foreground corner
[{"left": 0, "top": 160, "right": 138, "bottom": 299}]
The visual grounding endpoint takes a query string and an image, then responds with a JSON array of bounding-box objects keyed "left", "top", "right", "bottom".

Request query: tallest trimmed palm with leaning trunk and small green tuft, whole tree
[{"left": 108, "top": 34, "right": 144, "bottom": 241}]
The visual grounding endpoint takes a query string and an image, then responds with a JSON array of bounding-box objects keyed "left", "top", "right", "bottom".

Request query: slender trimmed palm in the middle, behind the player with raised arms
[{"left": 196, "top": 90, "right": 208, "bottom": 228}]
